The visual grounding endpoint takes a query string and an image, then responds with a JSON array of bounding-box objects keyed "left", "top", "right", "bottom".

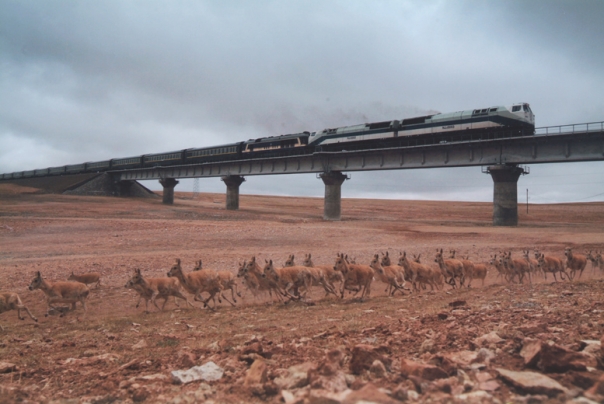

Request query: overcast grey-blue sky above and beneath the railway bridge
[{"left": 0, "top": 0, "right": 604, "bottom": 203}]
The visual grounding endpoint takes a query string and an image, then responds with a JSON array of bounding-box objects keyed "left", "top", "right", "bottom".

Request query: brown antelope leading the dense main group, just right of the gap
[{"left": 125, "top": 268, "right": 195, "bottom": 312}]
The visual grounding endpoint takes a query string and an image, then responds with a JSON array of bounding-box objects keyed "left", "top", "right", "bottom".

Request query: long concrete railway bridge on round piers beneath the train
[{"left": 1, "top": 122, "right": 604, "bottom": 226}]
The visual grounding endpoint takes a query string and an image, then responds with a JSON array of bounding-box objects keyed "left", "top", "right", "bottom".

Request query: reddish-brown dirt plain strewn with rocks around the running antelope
[{"left": 0, "top": 184, "right": 604, "bottom": 403}]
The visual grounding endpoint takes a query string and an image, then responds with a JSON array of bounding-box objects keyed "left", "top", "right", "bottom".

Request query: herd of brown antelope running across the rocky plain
[{"left": 0, "top": 248, "right": 604, "bottom": 329}]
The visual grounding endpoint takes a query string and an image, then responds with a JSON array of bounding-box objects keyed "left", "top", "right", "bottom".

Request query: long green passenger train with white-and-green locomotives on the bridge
[{"left": 0, "top": 102, "right": 535, "bottom": 179}]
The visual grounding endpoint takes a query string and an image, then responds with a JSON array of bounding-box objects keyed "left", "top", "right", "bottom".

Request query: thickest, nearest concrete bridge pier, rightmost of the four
[{"left": 487, "top": 165, "right": 526, "bottom": 226}]
